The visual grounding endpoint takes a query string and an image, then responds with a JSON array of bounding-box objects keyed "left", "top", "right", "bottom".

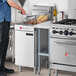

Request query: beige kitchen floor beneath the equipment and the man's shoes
[{"left": 6, "top": 62, "right": 76, "bottom": 76}]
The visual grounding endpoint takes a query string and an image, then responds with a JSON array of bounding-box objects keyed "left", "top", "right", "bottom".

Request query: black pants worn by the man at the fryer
[{"left": 0, "top": 21, "right": 10, "bottom": 68}]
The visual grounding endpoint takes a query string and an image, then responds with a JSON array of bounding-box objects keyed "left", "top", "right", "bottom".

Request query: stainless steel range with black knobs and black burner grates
[{"left": 50, "top": 19, "right": 76, "bottom": 72}]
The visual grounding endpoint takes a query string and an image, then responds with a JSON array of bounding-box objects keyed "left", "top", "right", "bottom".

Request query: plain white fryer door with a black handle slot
[{"left": 15, "top": 31, "right": 34, "bottom": 67}]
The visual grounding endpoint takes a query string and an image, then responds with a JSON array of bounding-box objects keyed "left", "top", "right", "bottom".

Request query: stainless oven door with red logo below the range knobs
[{"left": 50, "top": 38, "right": 76, "bottom": 66}]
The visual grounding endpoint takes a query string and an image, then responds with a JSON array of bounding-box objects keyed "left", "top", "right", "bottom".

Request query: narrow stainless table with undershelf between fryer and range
[{"left": 34, "top": 21, "right": 51, "bottom": 75}]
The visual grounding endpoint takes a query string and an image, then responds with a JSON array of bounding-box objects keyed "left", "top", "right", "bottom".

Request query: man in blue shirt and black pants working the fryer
[{"left": 0, "top": 0, "right": 26, "bottom": 76}]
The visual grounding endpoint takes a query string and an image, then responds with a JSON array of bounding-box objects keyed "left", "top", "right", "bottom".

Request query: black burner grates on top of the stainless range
[{"left": 54, "top": 19, "right": 76, "bottom": 25}]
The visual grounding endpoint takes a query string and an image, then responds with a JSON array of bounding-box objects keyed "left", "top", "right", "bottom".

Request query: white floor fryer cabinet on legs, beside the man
[{"left": 15, "top": 23, "right": 37, "bottom": 72}]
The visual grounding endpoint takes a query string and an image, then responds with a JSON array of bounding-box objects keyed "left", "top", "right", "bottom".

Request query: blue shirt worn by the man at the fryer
[{"left": 0, "top": 0, "right": 11, "bottom": 22}]
